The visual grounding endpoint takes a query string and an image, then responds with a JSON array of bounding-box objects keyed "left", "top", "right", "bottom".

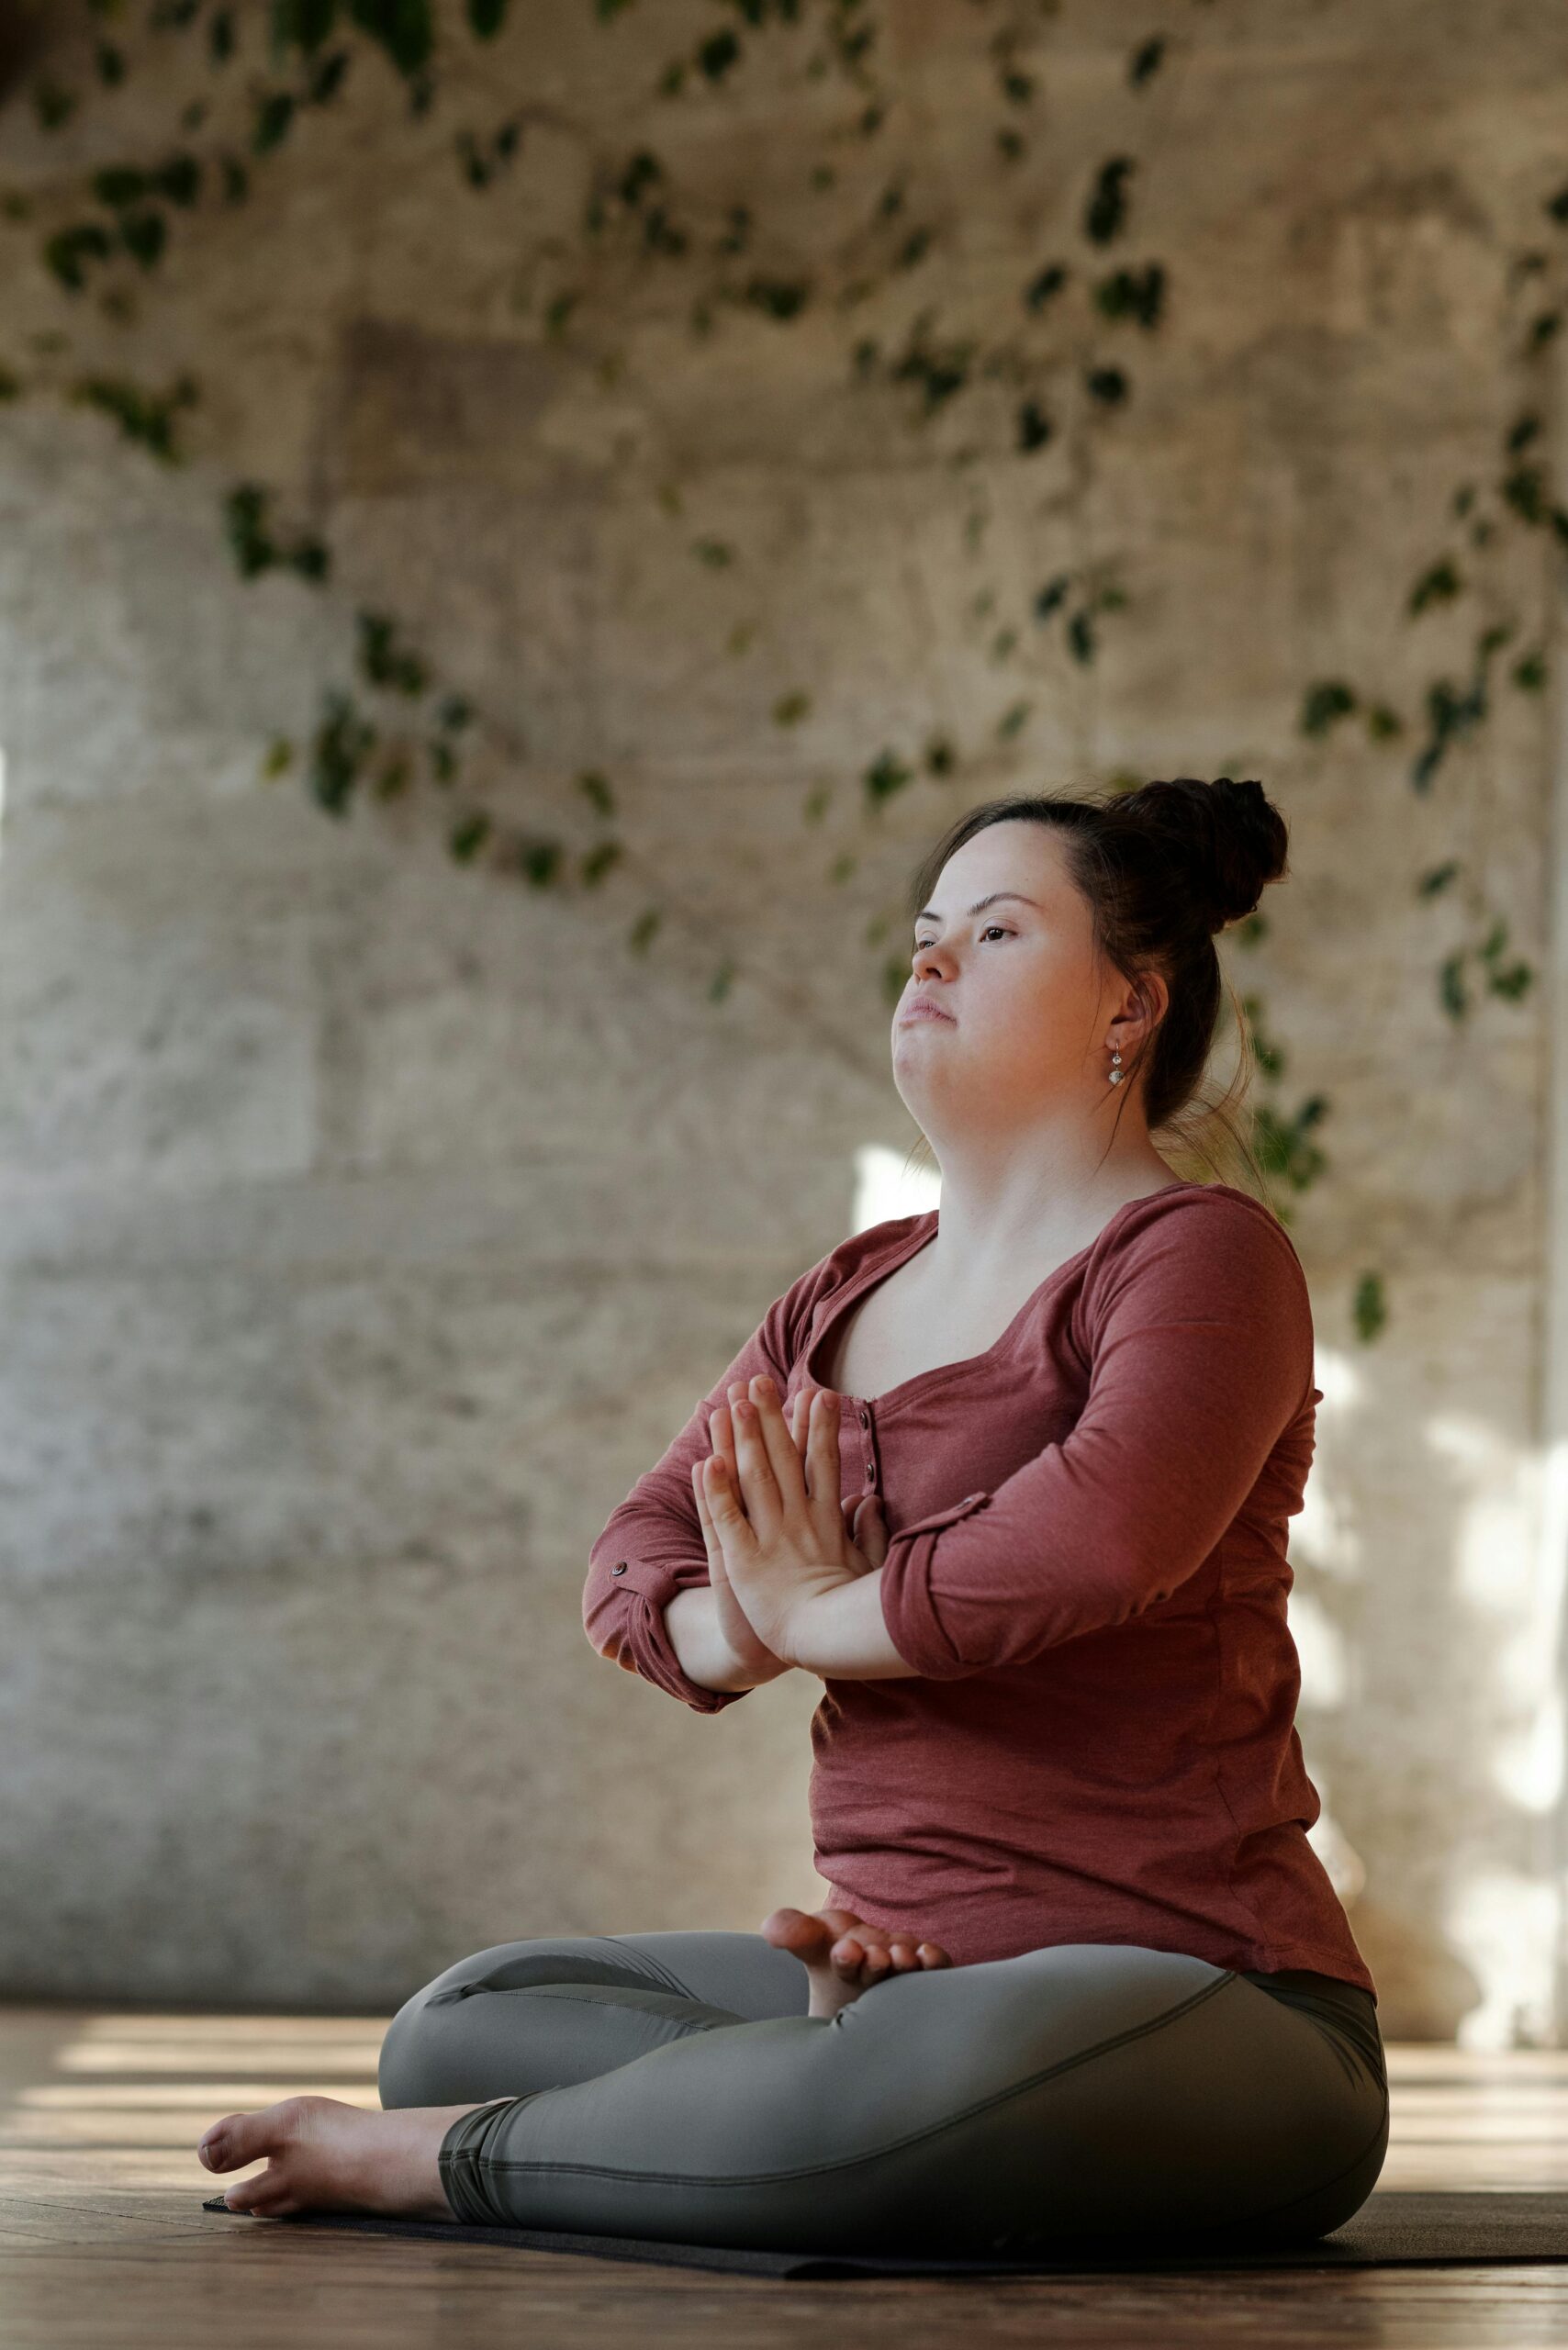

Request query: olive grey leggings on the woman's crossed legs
[{"left": 378, "top": 1934, "right": 1389, "bottom": 2258}]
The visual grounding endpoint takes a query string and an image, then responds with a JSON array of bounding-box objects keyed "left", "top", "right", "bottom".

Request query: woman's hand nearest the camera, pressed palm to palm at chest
[{"left": 703, "top": 1375, "right": 875, "bottom": 1663}]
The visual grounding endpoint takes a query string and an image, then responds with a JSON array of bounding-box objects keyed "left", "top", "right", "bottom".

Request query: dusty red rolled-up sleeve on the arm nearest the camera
[{"left": 881, "top": 1193, "right": 1312, "bottom": 1680}]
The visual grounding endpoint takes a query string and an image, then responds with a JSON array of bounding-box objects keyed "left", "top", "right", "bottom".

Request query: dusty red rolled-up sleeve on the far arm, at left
[{"left": 583, "top": 1258, "right": 827, "bottom": 1713}]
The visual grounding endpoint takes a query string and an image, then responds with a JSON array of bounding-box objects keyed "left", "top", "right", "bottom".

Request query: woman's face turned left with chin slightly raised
[{"left": 893, "top": 818, "right": 1131, "bottom": 1135}]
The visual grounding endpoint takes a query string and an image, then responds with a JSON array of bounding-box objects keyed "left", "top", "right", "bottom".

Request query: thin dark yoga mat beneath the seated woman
[{"left": 202, "top": 2188, "right": 1568, "bottom": 2277}]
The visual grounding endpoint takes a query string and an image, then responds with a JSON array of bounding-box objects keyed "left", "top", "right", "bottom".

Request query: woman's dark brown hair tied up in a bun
[{"left": 910, "top": 776, "right": 1288, "bottom": 1193}]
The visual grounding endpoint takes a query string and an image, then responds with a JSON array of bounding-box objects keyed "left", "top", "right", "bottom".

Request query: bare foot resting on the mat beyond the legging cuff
[{"left": 196, "top": 2097, "right": 485, "bottom": 2219}]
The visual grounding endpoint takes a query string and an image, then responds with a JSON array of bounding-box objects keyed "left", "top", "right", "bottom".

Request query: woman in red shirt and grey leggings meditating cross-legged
[{"left": 200, "top": 778, "right": 1389, "bottom": 2258}]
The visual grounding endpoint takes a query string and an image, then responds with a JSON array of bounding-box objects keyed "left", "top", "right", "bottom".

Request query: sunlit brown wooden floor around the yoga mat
[{"left": 0, "top": 2007, "right": 1568, "bottom": 2350}]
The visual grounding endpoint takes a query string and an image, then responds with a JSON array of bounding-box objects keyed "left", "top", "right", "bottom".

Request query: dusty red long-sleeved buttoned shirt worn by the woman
[{"left": 583, "top": 1182, "right": 1378, "bottom": 1998}]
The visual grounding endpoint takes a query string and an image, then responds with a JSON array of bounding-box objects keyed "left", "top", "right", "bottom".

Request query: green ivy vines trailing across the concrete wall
[{"left": 0, "top": 0, "right": 1523, "bottom": 1335}]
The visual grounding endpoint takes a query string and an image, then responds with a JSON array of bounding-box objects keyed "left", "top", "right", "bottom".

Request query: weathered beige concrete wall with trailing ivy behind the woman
[{"left": 0, "top": 0, "right": 1568, "bottom": 2049}]
